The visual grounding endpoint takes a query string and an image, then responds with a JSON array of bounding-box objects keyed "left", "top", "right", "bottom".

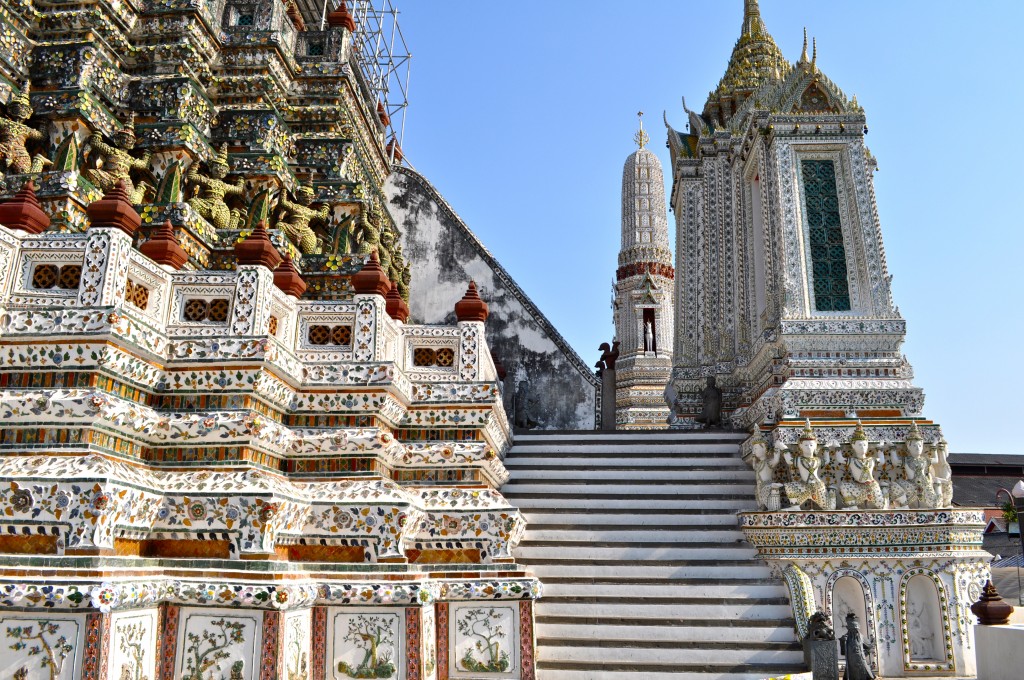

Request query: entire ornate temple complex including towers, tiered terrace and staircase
[{"left": 0, "top": 0, "right": 1007, "bottom": 680}]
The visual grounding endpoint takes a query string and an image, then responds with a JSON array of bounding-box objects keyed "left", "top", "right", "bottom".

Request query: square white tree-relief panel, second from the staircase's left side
[{"left": 333, "top": 611, "right": 403, "bottom": 680}]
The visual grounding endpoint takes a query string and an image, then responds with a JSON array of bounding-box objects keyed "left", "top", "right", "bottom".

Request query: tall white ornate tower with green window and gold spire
[{"left": 669, "top": 0, "right": 924, "bottom": 440}]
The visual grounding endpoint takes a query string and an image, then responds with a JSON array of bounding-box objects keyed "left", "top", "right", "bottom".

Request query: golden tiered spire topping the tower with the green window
[{"left": 703, "top": 0, "right": 793, "bottom": 127}]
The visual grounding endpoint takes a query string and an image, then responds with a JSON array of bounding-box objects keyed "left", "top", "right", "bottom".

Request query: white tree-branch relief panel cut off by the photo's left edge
[{"left": 0, "top": 619, "right": 80, "bottom": 680}]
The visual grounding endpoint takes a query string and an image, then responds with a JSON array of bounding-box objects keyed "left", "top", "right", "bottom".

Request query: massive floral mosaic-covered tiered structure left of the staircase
[{"left": 0, "top": 0, "right": 540, "bottom": 680}]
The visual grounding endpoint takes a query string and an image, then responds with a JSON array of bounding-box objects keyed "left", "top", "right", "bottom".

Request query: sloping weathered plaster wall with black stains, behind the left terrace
[{"left": 385, "top": 168, "right": 600, "bottom": 429}]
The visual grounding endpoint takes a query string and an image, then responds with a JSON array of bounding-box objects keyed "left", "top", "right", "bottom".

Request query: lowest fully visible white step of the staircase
[{"left": 538, "top": 640, "right": 804, "bottom": 666}]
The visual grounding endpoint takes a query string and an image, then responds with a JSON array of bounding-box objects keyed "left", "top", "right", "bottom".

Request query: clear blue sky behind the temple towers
[{"left": 396, "top": 0, "right": 1024, "bottom": 454}]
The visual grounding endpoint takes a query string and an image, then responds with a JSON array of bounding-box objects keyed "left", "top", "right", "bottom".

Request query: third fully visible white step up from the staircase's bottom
[{"left": 537, "top": 597, "right": 793, "bottom": 625}]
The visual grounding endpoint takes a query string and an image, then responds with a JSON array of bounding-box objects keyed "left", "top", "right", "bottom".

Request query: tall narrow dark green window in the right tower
[{"left": 801, "top": 161, "right": 850, "bottom": 311}]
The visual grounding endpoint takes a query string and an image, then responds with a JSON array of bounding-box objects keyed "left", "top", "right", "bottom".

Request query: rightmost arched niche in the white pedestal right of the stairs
[{"left": 900, "top": 569, "right": 954, "bottom": 671}]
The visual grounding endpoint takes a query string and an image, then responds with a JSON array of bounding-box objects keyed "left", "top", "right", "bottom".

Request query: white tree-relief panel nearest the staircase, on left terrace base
[{"left": 453, "top": 607, "right": 518, "bottom": 675}]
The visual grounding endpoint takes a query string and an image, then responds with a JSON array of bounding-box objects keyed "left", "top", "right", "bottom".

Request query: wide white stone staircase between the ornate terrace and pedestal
[{"left": 502, "top": 431, "right": 805, "bottom": 680}]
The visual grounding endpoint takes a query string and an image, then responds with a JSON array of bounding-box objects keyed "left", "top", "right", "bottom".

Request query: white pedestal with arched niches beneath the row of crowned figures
[{"left": 739, "top": 509, "right": 991, "bottom": 678}]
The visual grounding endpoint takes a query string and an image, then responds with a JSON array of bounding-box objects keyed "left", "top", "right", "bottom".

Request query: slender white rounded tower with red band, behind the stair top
[{"left": 613, "top": 113, "right": 675, "bottom": 429}]
